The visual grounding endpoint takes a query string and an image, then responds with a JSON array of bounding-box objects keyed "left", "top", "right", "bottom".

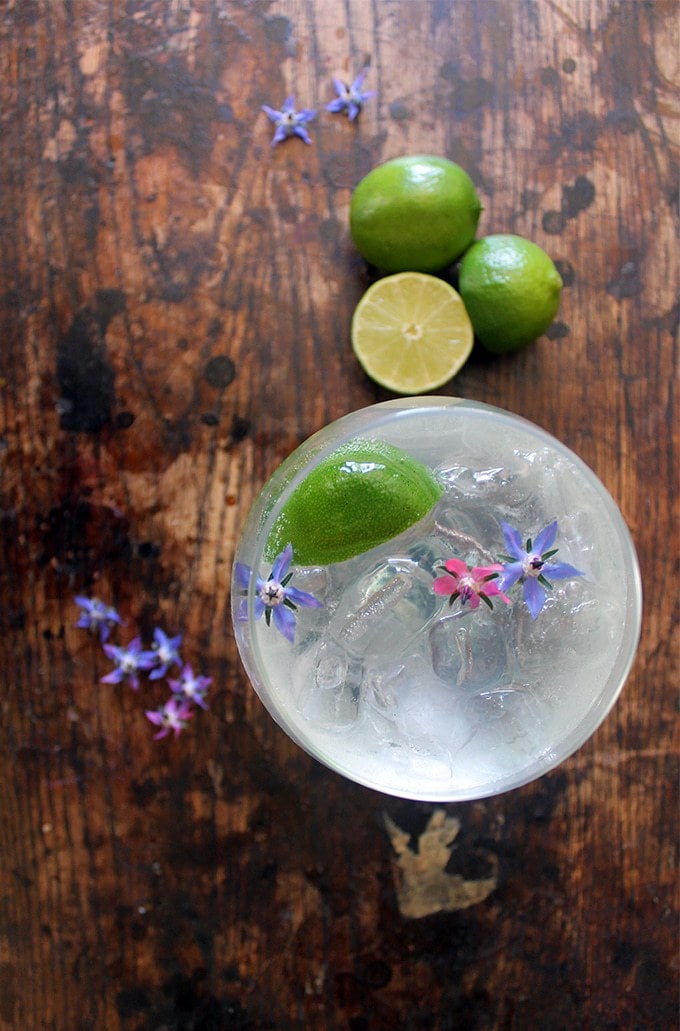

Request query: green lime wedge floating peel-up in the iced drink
[{"left": 265, "top": 438, "right": 442, "bottom": 566}]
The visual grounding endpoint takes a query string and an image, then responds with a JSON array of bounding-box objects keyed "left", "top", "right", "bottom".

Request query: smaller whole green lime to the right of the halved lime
[{"left": 458, "top": 234, "right": 562, "bottom": 355}]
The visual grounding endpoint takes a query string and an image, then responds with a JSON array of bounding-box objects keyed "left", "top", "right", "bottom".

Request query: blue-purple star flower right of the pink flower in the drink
[{"left": 499, "top": 520, "right": 583, "bottom": 620}]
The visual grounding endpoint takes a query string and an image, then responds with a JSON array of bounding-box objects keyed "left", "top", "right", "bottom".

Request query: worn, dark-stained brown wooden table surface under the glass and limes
[{"left": 0, "top": 0, "right": 680, "bottom": 1031}]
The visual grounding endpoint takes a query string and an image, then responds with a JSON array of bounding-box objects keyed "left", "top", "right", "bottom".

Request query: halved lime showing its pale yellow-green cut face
[{"left": 351, "top": 272, "right": 474, "bottom": 394}]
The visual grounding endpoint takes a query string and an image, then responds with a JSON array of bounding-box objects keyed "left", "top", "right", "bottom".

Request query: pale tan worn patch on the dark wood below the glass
[{"left": 383, "top": 809, "right": 498, "bottom": 918}]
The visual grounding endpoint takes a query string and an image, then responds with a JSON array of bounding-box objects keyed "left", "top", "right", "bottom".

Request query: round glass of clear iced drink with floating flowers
[{"left": 232, "top": 397, "right": 641, "bottom": 801}]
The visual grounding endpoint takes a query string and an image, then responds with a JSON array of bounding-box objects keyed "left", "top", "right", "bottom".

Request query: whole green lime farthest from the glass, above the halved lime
[{"left": 349, "top": 155, "right": 481, "bottom": 272}]
